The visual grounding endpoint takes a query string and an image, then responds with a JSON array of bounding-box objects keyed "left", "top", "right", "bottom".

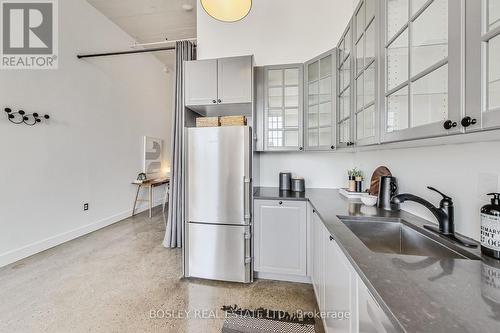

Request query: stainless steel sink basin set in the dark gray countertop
[{"left": 342, "top": 220, "right": 476, "bottom": 259}]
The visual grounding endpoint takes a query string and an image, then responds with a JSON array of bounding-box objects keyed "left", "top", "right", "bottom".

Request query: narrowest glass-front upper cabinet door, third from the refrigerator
[{"left": 336, "top": 22, "right": 354, "bottom": 148}]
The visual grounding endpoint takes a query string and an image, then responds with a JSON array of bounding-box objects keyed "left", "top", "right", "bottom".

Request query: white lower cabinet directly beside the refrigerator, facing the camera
[{"left": 254, "top": 200, "right": 307, "bottom": 281}]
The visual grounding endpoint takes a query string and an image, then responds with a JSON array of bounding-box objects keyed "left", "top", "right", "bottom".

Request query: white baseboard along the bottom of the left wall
[{"left": 0, "top": 201, "right": 162, "bottom": 267}]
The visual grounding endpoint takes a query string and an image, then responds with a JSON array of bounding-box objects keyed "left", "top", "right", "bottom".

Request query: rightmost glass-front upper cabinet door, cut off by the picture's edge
[{"left": 462, "top": 0, "right": 500, "bottom": 131}]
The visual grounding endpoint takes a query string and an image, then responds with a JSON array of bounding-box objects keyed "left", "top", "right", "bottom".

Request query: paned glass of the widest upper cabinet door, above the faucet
[{"left": 385, "top": 0, "right": 449, "bottom": 133}]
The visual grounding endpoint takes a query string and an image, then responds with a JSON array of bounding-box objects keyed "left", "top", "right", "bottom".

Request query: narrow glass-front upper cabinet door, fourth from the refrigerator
[{"left": 353, "top": 0, "right": 379, "bottom": 145}]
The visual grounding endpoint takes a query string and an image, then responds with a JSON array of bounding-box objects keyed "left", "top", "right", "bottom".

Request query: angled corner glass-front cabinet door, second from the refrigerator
[{"left": 304, "top": 49, "right": 336, "bottom": 151}]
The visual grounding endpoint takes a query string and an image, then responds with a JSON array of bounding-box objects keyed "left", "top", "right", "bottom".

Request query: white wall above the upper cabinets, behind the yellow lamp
[{"left": 197, "top": 0, "right": 358, "bottom": 66}]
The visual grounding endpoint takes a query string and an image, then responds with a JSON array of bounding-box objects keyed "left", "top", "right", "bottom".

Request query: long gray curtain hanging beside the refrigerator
[{"left": 163, "top": 41, "right": 196, "bottom": 248}]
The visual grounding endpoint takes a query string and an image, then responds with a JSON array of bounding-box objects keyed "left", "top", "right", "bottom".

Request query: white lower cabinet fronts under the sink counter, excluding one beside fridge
[{"left": 310, "top": 213, "right": 396, "bottom": 333}]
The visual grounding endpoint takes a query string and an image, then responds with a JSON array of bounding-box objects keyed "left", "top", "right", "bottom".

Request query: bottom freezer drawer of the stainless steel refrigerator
[{"left": 187, "top": 223, "right": 251, "bottom": 282}]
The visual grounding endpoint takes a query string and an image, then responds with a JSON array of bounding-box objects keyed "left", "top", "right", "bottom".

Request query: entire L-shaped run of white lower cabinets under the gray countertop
[{"left": 254, "top": 200, "right": 397, "bottom": 333}]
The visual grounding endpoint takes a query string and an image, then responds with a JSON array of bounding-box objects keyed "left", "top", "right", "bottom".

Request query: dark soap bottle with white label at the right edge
[{"left": 481, "top": 193, "right": 500, "bottom": 260}]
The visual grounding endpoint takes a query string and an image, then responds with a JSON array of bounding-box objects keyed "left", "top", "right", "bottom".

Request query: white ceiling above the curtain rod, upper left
[{"left": 87, "top": 0, "right": 196, "bottom": 67}]
